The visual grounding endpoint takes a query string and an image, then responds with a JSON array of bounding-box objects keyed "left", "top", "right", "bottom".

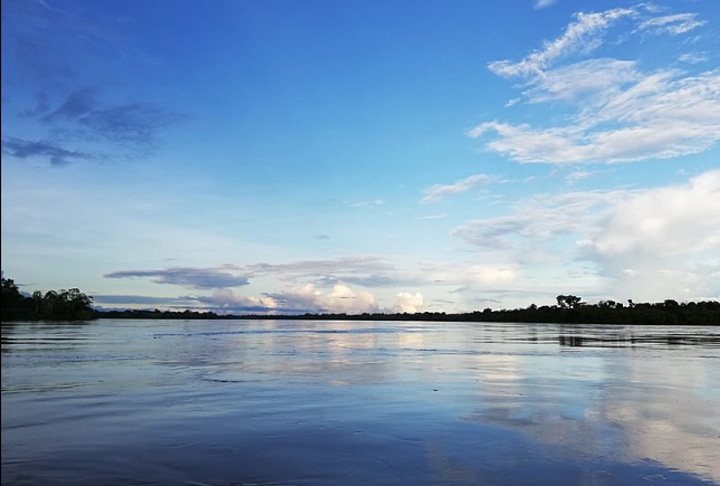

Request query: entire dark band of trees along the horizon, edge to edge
[{"left": 1, "top": 277, "right": 720, "bottom": 325}]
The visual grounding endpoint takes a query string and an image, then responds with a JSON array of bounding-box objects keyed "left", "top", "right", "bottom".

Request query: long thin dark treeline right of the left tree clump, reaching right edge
[{"left": 96, "top": 295, "right": 720, "bottom": 326}]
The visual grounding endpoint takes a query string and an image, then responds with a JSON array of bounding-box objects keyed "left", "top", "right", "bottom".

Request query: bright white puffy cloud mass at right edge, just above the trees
[{"left": 580, "top": 170, "right": 720, "bottom": 300}]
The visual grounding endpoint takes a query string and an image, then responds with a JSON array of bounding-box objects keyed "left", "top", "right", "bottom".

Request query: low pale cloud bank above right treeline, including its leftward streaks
[{"left": 452, "top": 170, "right": 720, "bottom": 301}]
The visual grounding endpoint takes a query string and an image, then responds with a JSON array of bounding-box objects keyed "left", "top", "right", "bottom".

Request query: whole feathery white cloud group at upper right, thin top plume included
[{"left": 468, "top": 8, "right": 720, "bottom": 164}]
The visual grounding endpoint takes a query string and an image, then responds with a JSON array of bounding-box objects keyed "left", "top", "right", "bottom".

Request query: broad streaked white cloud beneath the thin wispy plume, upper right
[{"left": 468, "top": 67, "right": 720, "bottom": 164}]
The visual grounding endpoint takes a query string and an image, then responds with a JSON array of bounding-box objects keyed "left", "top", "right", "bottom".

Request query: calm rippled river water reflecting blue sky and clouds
[{"left": 2, "top": 320, "right": 720, "bottom": 486}]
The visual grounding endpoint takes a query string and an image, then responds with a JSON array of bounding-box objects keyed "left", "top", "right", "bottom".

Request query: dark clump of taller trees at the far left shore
[{"left": 0, "top": 277, "right": 97, "bottom": 322}]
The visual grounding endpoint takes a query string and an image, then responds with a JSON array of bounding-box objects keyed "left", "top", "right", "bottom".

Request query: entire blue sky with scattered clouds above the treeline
[{"left": 1, "top": 0, "right": 720, "bottom": 314}]
